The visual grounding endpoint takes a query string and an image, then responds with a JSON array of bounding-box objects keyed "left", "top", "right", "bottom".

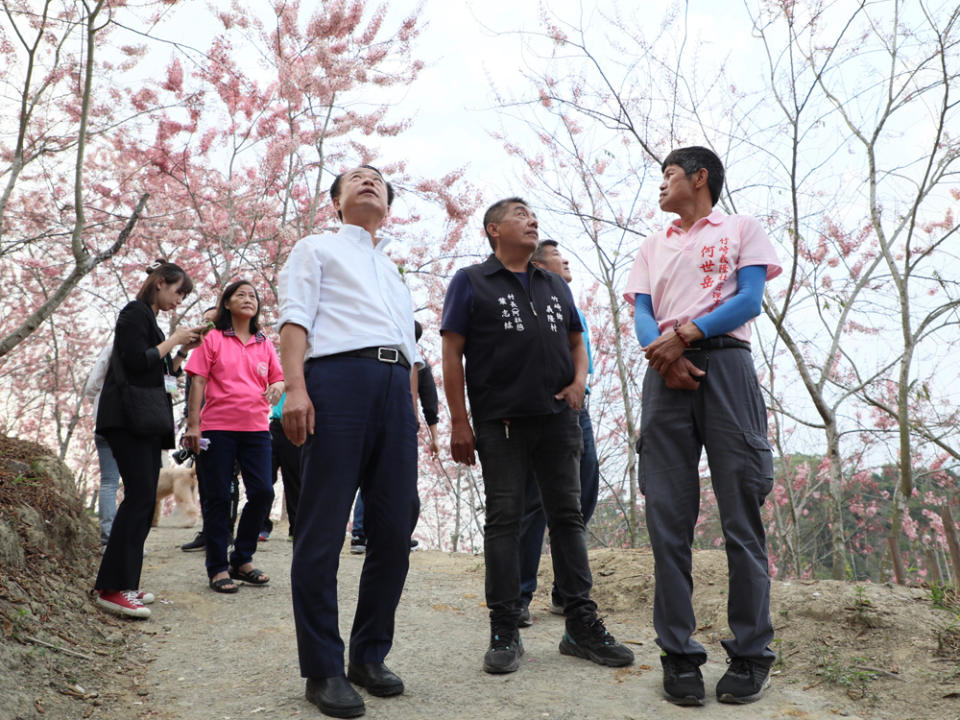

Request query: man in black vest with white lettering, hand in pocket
[{"left": 440, "top": 198, "right": 633, "bottom": 673}]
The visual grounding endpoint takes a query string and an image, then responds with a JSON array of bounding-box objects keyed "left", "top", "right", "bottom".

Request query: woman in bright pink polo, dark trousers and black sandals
[{"left": 183, "top": 280, "right": 283, "bottom": 593}]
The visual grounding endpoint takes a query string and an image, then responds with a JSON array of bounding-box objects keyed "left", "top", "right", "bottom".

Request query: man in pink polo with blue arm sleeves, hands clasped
[{"left": 624, "top": 147, "right": 781, "bottom": 705}]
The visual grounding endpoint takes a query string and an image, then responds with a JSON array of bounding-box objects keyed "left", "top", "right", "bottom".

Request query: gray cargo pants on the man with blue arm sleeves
[{"left": 637, "top": 348, "right": 775, "bottom": 664}]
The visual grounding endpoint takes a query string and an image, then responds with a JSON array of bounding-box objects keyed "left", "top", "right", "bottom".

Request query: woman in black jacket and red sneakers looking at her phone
[{"left": 94, "top": 260, "right": 201, "bottom": 618}]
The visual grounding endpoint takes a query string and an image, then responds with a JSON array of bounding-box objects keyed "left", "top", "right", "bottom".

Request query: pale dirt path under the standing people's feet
[{"left": 124, "top": 528, "right": 872, "bottom": 720}]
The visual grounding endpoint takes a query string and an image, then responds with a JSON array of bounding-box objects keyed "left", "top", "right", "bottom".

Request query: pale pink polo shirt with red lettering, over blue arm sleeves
[{"left": 623, "top": 210, "right": 783, "bottom": 340}]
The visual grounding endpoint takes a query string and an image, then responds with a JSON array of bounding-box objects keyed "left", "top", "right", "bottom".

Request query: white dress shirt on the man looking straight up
[{"left": 277, "top": 225, "right": 421, "bottom": 368}]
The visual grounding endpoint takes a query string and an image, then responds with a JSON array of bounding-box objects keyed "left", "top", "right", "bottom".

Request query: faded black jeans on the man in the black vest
[{"left": 476, "top": 408, "right": 597, "bottom": 626}]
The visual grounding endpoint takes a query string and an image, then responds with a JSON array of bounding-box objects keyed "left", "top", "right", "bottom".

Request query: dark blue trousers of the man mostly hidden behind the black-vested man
[{"left": 520, "top": 405, "right": 600, "bottom": 607}]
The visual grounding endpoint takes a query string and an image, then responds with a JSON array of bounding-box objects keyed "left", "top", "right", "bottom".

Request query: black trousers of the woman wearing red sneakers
[{"left": 94, "top": 430, "right": 161, "bottom": 591}]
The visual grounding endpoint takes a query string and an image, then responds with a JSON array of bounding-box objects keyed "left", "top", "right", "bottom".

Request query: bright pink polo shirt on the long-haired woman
[{"left": 185, "top": 329, "right": 283, "bottom": 432}]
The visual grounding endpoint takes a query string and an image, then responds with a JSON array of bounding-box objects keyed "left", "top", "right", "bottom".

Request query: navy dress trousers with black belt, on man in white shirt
[{"left": 290, "top": 357, "right": 420, "bottom": 678}]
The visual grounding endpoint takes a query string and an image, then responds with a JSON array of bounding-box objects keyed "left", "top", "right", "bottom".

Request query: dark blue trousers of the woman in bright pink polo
[{"left": 197, "top": 430, "right": 273, "bottom": 577}]
